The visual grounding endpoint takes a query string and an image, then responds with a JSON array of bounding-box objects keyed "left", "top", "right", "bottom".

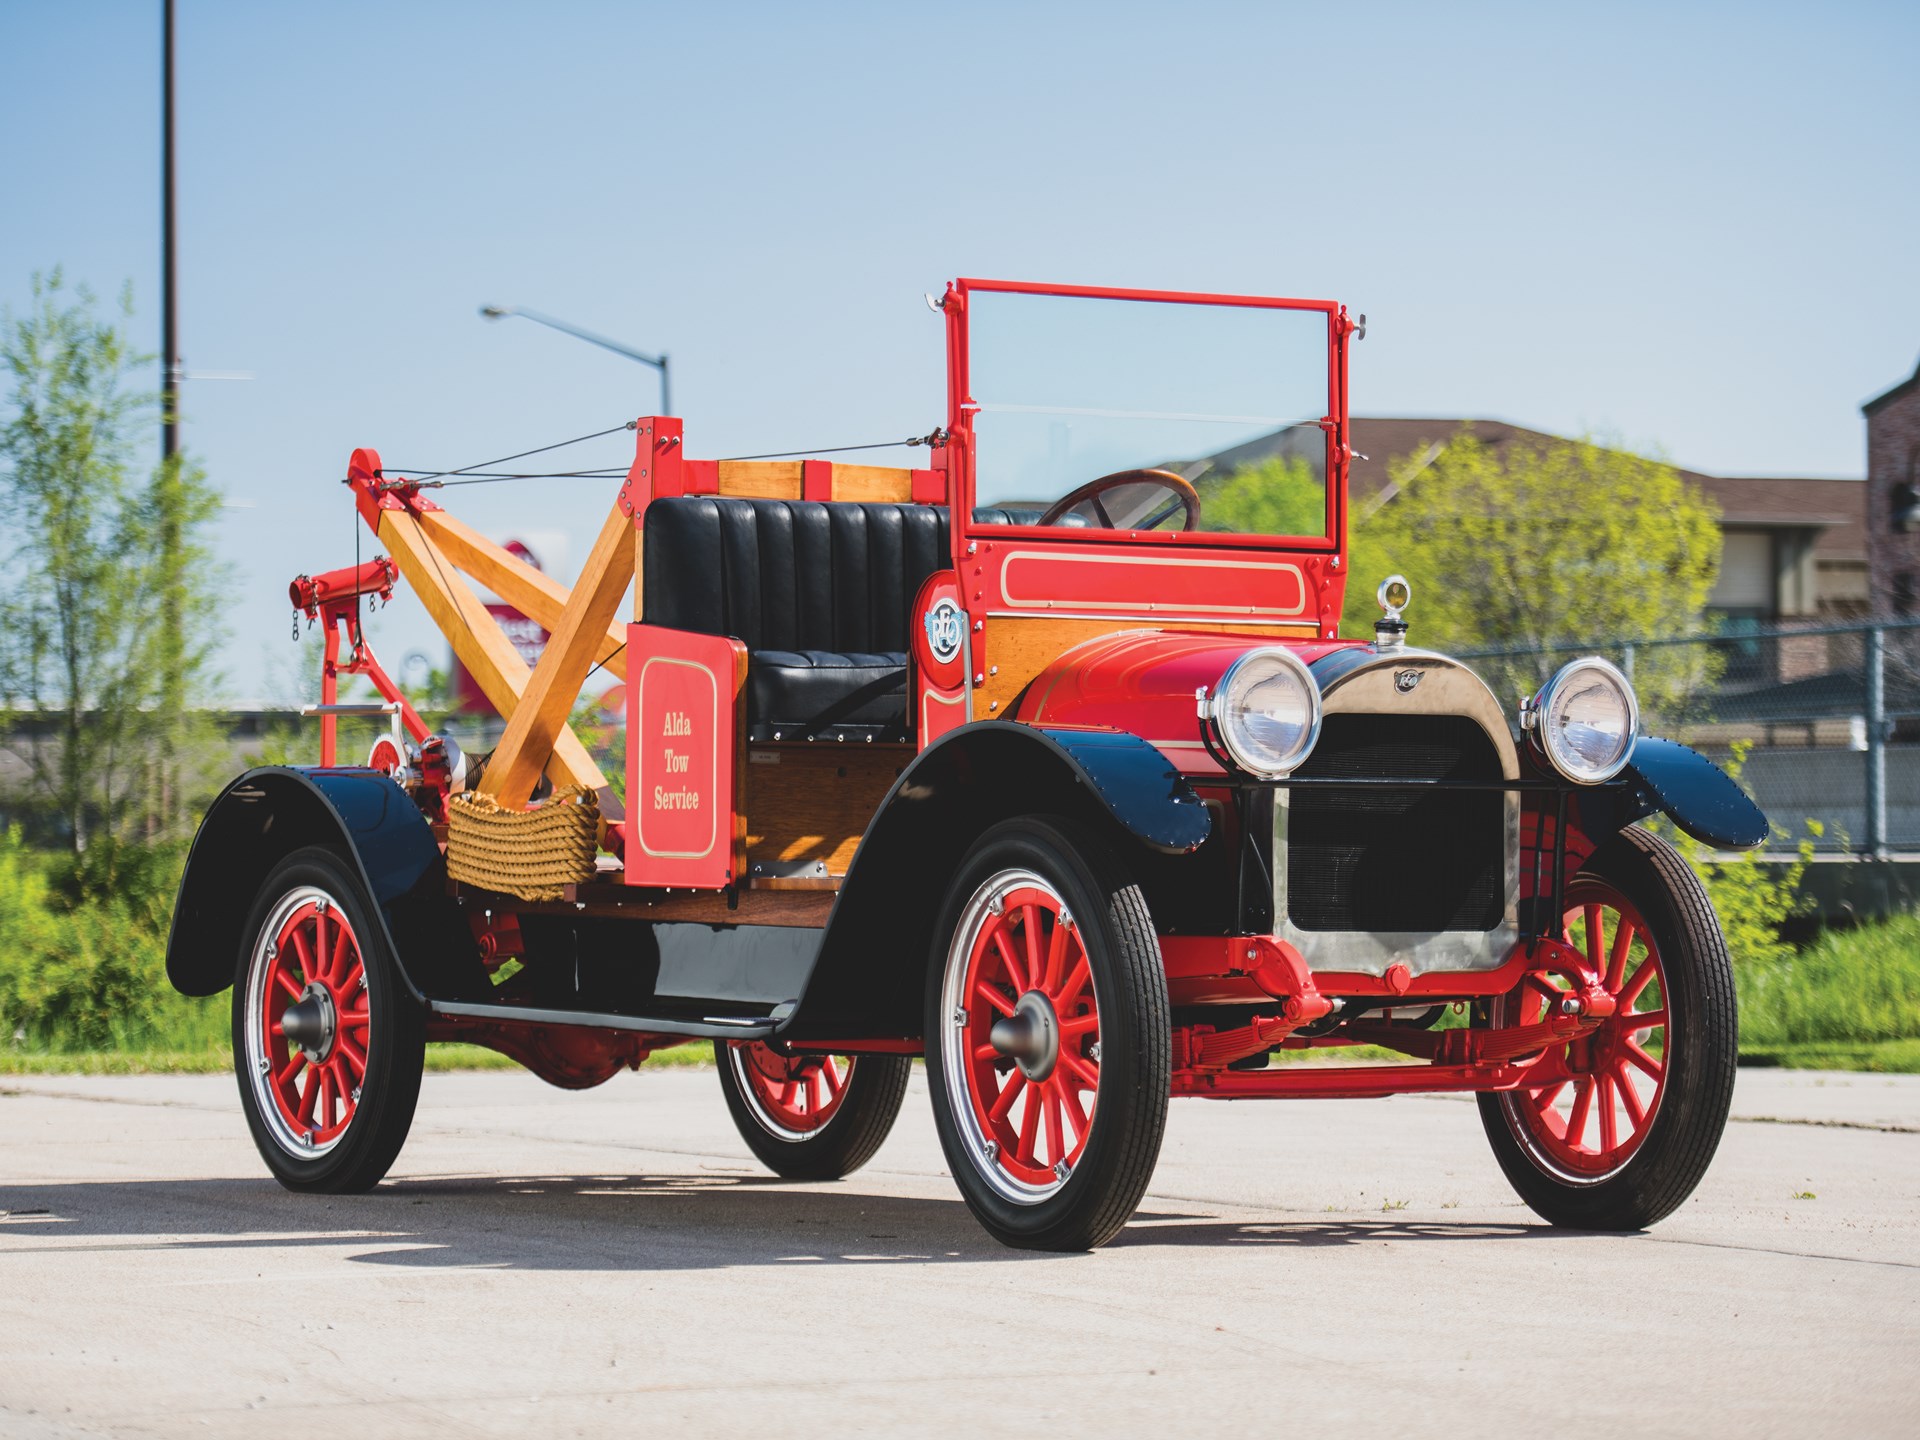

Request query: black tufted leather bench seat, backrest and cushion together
[{"left": 641, "top": 495, "right": 948, "bottom": 741}]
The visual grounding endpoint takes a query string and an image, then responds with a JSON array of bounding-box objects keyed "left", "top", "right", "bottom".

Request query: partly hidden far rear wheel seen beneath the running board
[{"left": 714, "top": 1041, "right": 914, "bottom": 1181}]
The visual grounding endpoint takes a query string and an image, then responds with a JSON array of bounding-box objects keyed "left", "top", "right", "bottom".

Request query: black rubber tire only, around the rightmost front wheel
[{"left": 1478, "top": 829, "right": 1740, "bottom": 1231}]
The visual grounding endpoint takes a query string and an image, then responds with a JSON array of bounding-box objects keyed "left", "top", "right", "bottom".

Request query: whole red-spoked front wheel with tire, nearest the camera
[{"left": 925, "top": 818, "right": 1173, "bottom": 1250}]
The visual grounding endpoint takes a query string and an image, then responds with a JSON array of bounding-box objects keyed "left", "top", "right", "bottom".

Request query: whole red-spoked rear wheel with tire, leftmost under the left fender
[{"left": 234, "top": 849, "right": 424, "bottom": 1190}]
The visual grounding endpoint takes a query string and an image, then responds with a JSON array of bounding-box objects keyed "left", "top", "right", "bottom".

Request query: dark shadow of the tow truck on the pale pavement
[{"left": 0, "top": 1171, "right": 1549, "bottom": 1271}]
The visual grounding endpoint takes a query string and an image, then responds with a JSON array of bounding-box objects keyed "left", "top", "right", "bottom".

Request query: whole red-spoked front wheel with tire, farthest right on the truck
[{"left": 1480, "top": 831, "right": 1738, "bottom": 1229}]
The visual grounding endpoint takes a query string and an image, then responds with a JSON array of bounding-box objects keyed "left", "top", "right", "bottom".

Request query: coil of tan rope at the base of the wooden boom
[{"left": 447, "top": 785, "right": 599, "bottom": 900}]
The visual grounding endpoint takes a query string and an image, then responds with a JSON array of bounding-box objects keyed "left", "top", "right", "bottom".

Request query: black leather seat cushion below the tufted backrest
[{"left": 747, "top": 651, "right": 908, "bottom": 741}]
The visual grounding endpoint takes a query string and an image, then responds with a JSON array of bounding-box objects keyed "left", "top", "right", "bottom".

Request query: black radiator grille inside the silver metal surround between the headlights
[{"left": 1286, "top": 714, "right": 1505, "bottom": 933}]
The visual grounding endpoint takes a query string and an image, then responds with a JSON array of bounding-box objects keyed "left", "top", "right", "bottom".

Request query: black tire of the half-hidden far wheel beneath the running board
[{"left": 714, "top": 1041, "right": 914, "bottom": 1181}]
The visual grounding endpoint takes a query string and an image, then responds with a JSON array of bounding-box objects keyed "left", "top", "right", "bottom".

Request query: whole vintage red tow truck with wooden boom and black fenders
[{"left": 167, "top": 280, "right": 1766, "bottom": 1250}]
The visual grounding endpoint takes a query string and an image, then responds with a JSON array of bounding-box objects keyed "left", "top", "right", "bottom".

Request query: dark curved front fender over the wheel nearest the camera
[{"left": 780, "top": 720, "right": 1213, "bottom": 1041}]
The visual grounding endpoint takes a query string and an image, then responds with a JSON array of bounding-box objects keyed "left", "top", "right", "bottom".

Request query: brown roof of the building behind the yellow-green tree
[{"left": 1350, "top": 416, "right": 1858, "bottom": 564}]
